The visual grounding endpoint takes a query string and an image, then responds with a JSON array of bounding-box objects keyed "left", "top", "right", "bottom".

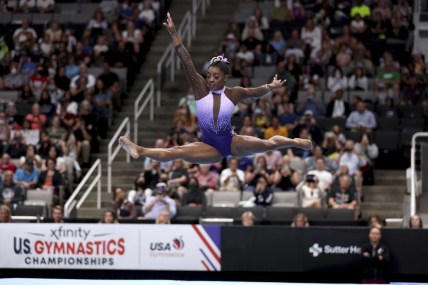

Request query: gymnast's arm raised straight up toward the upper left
[{"left": 164, "top": 13, "right": 209, "bottom": 99}]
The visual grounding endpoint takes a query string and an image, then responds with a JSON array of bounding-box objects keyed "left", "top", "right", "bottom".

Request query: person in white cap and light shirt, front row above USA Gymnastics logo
[{"left": 143, "top": 182, "right": 177, "bottom": 220}]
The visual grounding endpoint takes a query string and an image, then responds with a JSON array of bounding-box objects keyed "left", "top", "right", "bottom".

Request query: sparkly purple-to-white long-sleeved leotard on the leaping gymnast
[{"left": 175, "top": 44, "right": 270, "bottom": 157}]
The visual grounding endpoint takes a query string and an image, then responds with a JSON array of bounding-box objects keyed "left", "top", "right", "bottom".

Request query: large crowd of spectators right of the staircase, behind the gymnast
[{"left": 96, "top": 0, "right": 427, "bottom": 223}]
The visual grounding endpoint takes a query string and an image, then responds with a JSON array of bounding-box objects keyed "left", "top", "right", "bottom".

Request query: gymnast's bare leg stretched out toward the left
[{"left": 119, "top": 136, "right": 223, "bottom": 164}]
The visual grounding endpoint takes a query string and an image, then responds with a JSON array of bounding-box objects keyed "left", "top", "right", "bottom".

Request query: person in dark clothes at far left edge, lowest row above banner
[{"left": 0, "top": 170, "right": 26, "bottom": 207}]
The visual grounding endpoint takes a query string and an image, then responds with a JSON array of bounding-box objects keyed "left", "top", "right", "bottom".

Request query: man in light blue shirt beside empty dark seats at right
[{"left": 346, "top": 102, "right": 377, "bottom": 132}]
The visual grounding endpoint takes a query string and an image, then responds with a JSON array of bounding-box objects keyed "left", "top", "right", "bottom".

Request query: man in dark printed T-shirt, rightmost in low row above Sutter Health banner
[{"left": 328, "top": 175, "right": 357, "bottom": 210}]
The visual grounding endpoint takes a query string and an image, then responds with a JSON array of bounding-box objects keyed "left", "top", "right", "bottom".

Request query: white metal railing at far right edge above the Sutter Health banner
[{"left": 410, "top": 132, "right": 428, "bottom": 215}]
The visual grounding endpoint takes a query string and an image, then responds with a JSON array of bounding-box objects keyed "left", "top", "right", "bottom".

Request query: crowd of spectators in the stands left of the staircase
[{"left": 0, "top": 0, "right": 162, "bottom": 211}]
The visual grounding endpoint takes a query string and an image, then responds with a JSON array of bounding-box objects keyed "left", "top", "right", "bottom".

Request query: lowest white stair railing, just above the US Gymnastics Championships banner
[{"left": 64, "top": 158, "right": 102, "bottom": 218}]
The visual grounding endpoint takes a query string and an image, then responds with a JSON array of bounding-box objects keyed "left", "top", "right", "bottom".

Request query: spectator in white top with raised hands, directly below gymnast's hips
[{"left": 220, "top": 157, "right": 246, "bottom": 191}]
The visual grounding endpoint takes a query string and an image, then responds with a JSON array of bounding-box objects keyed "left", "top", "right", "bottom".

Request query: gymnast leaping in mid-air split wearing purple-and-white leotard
[{"left": 119, "top": 13, "right": 312, "bottom": 164}]
